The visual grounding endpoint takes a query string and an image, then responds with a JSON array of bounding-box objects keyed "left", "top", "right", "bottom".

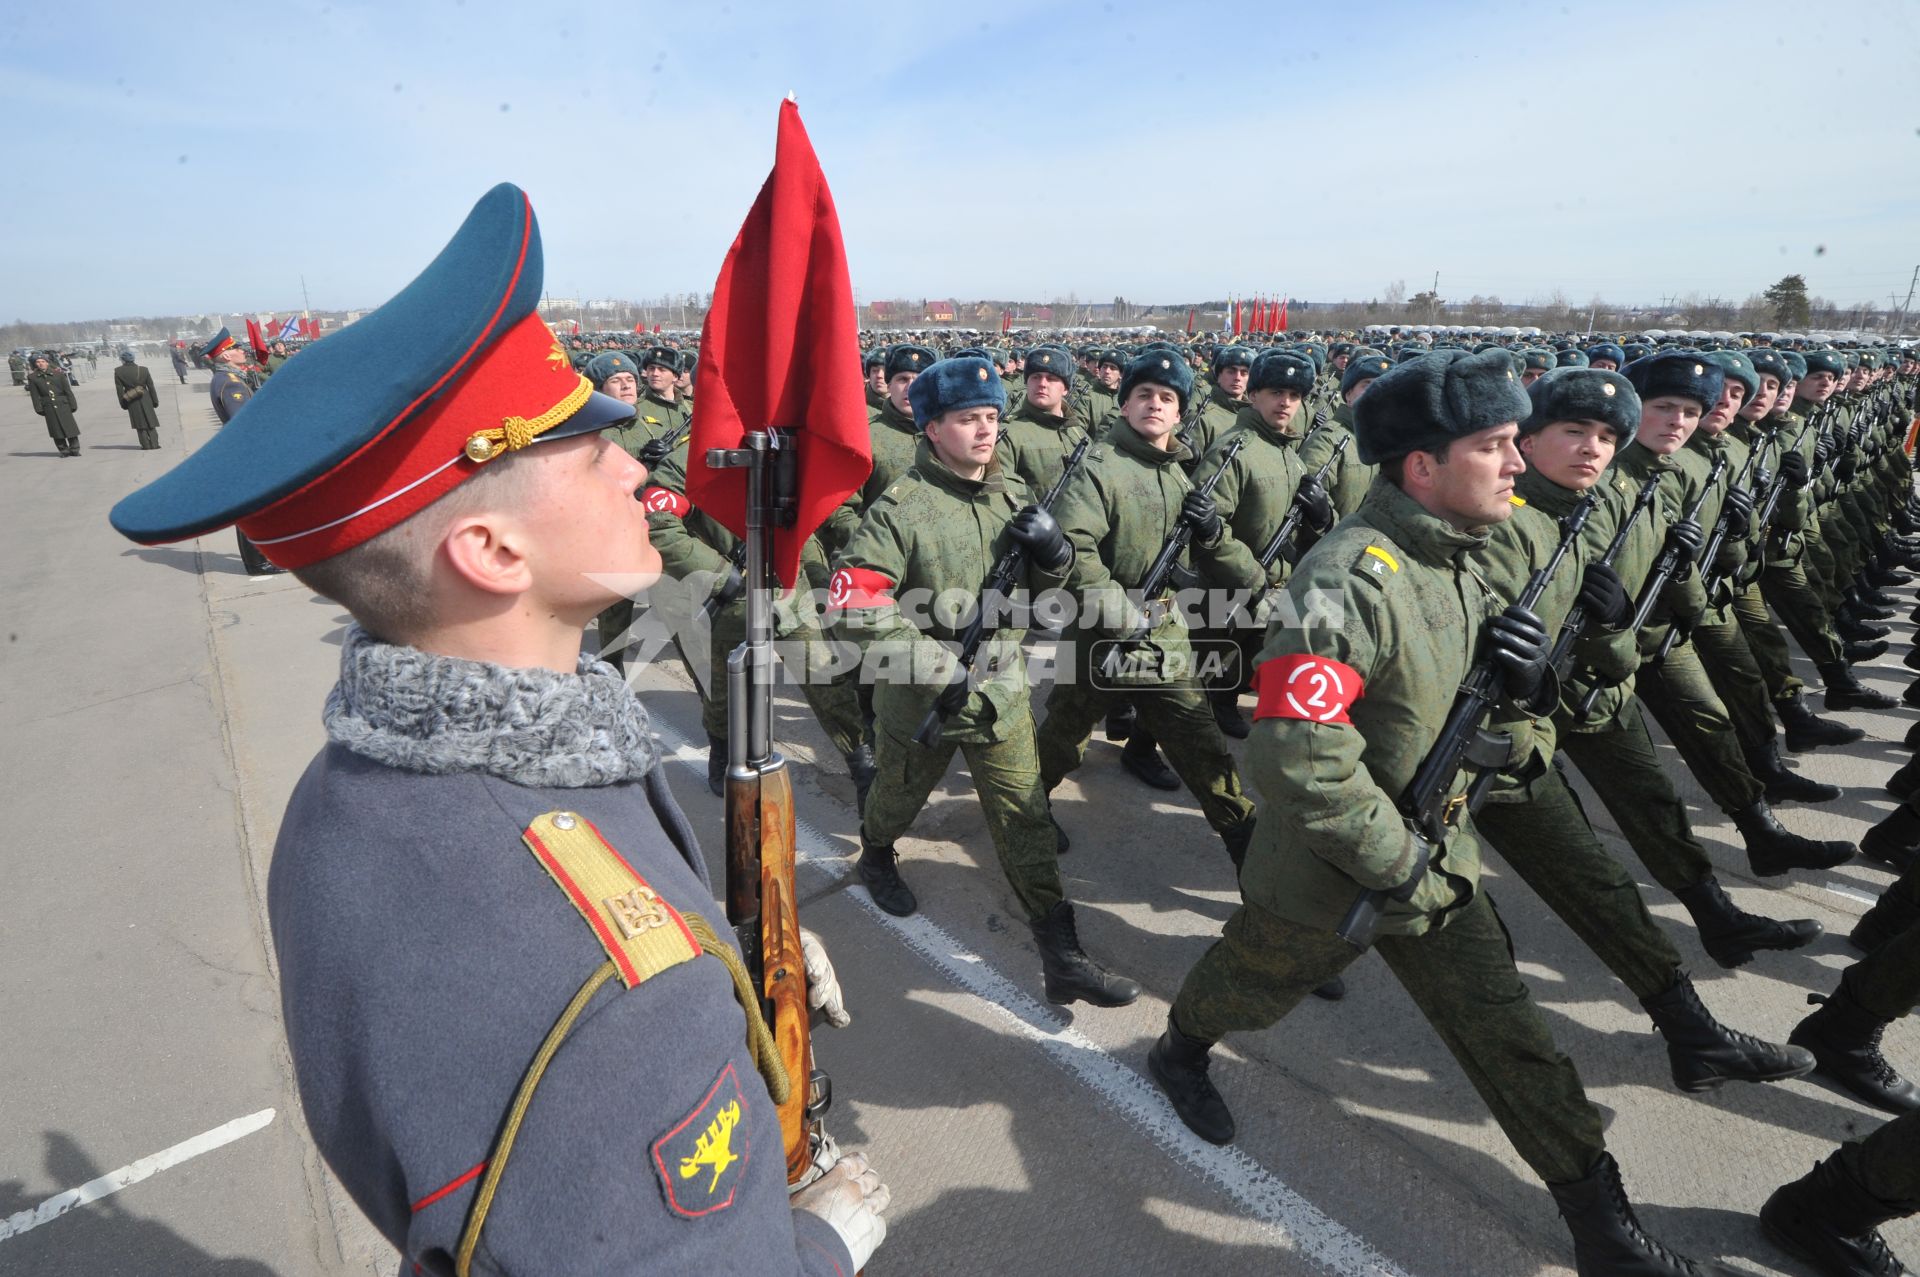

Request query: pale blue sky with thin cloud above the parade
[{"left": 0, "top": 0, "right": 1920, "bottom": 321}]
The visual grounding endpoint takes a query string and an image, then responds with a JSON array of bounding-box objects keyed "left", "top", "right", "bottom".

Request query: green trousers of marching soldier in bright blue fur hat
[{"left": 862, "top": 701, "right": 1066, "bottom": 922}]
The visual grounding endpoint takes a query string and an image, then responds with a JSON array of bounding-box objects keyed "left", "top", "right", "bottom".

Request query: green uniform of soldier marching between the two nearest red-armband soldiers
[{"left": 1039, "top": 421, "right": 1254, "bottom": 833}]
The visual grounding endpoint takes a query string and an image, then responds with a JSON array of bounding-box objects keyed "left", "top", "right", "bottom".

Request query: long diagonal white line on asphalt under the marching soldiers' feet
[{"left": 653, "top": 718, "right": 1407, "bottom": 1277}]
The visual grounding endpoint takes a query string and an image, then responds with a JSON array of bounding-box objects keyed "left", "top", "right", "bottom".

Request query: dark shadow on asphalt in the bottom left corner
[{"left": 0, "top": 1131, "right": 276, "bottom": 1277}]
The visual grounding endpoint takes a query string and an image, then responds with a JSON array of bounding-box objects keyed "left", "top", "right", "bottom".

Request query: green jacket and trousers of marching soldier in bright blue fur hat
[{"left": 828, "top": 440, "right": 1066, "bottom": 922}]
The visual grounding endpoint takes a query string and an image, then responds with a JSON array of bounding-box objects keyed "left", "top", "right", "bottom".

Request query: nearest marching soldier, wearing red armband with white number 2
[{"left": 1148, "top": 343, "right": 1724, "bottom": 1277}]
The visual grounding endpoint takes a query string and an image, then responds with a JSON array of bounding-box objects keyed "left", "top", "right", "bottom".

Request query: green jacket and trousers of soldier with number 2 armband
[{"left": 1171, "top": 484, "right": 1605, "bottom": 1183}]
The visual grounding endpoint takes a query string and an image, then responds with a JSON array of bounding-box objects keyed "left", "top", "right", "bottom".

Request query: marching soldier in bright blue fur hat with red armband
[{"left": 828, "top": 357, "right": 1140, "bottom": 1006}]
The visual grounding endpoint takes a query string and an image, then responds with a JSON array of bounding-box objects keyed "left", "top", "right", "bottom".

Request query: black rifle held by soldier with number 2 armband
[{"left": 1334, "top": 486, "right": 1599, "bottom": 951}]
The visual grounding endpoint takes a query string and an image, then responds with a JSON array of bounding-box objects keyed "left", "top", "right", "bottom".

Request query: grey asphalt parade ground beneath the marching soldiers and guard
[{"left": 0, "top": 361, "right": 1920, "bottom": 1277}]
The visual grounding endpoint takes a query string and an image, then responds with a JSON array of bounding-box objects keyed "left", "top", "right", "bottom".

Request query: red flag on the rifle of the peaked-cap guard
[{"left": 687, "top": 100, "right": 874, "bottom": 586}]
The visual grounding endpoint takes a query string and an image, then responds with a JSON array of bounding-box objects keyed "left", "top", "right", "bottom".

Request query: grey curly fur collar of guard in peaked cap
[{"left": 323, "top": 626, "right": 660, "bottom": 789}]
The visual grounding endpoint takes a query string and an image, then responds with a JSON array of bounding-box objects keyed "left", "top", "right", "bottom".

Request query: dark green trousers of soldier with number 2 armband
[{"left": 1171, "top": 887, "right": 1607, "bottom": 1183}]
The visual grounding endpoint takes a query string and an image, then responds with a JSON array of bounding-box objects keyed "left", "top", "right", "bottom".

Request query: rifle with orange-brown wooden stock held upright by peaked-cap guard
[{"left": 707, "top": 430, "right": 833, "bottom": 1183}]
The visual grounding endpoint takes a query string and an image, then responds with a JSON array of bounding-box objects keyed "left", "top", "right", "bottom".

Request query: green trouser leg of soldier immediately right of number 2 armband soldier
[{"left": 1473, "top": 766, "right": 1680, "bottom": 999}]
